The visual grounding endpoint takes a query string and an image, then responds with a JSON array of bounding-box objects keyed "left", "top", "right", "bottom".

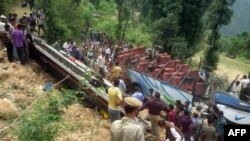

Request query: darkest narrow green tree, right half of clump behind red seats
[{"left": 179, "top": 0, "right": 212, "bottom": 56}]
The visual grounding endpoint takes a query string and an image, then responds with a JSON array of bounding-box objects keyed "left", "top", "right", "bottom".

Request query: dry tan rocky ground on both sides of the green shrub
[{"left": 0, "top": 43, "right": 110, "bottom": 141}]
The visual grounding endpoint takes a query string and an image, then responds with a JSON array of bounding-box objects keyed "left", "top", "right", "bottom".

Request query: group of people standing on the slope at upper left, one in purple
[{"left": 0, "top": 0, "right": 46, "bottom": 65}]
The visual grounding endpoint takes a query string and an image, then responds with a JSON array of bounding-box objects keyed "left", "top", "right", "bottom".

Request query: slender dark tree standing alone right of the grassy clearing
[{"left": 204, "top": 0, "right": 234, "bottom": 71}]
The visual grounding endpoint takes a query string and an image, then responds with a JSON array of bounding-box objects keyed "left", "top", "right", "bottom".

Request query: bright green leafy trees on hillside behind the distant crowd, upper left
[{"left": 35, "top": 0, "right": 151, "bottom": 46}]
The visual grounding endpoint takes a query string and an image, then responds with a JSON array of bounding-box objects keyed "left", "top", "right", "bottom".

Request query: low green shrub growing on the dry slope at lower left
[{"left": 16, "top": 89, "right": 76, "bottom": 141}]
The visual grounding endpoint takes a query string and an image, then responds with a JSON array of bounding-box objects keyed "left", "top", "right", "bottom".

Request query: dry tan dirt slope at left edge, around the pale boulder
[{"left": 0, "top": 45, "right": 55, "bottom": 140}]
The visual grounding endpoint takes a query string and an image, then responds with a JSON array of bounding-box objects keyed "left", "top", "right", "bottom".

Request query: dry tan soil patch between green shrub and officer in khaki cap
[{"left": 55, "top": 104, "right": 110, "bottom": 141}]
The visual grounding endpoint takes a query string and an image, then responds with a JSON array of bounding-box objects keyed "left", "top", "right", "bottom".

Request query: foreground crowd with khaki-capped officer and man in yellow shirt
[{"left": 108, "top": 82, "right": 227, "bottom": 141}]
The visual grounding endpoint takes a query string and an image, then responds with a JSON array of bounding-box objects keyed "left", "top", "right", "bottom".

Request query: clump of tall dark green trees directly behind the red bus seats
[{"left": 150, "top": 0, "right": 211, "bottom": 58}]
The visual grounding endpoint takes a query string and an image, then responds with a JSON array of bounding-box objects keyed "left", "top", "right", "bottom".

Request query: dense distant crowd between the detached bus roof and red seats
[{"left": 52, "top": 29, "right": 131, "bottom": 80}]
